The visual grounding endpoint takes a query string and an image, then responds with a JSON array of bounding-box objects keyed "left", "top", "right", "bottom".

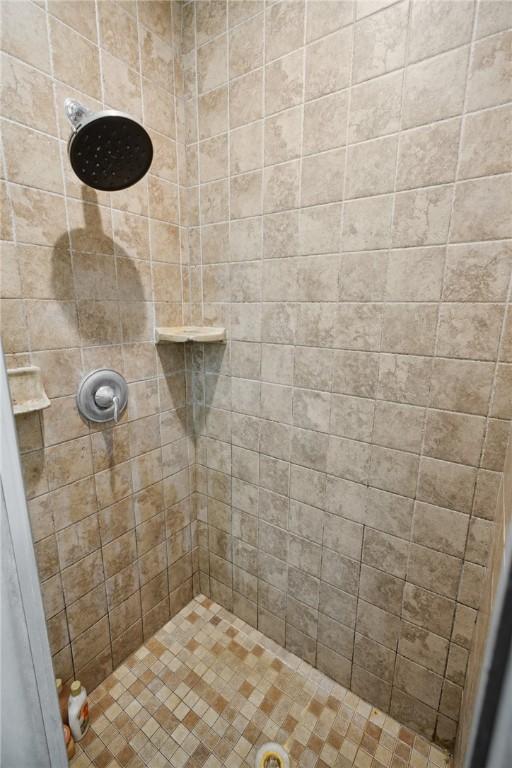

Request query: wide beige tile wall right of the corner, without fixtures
[{"left": 182, "top": 0, "right": 512, "bottom": 746}]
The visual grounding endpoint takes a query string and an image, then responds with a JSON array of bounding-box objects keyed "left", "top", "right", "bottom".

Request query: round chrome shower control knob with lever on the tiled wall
[{"left": 77, "top": 368, "right": 128, "bottom": 423}]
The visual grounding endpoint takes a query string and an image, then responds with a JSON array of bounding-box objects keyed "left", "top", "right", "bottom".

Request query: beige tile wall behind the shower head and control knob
[{"left": 1, "top": 0, "right": 197, "bottom": 688}]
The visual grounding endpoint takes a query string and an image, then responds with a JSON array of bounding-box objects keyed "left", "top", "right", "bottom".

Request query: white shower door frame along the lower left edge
[{"left": 0, "top": 342, "right": 68, "bottom": 768}]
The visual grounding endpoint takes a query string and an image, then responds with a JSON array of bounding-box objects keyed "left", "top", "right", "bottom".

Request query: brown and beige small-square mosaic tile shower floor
[{"left": 72, "top": 596, "right": 449, "bottom": 768}]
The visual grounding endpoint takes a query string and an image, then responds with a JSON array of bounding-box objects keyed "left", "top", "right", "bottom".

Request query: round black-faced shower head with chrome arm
[{"left": 64, "top": 99, "right": 153, "bottom": 192}]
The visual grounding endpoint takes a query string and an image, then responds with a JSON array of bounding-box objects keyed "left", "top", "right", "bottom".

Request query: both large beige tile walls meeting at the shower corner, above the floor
[{"left": 1, "top": 0, "right": 512, "bottom": 768}]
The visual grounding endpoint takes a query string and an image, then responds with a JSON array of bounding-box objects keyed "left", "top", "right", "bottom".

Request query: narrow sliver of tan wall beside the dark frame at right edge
[{"left": 455, "top": 424, "right": 512, "bottom": 766}]
